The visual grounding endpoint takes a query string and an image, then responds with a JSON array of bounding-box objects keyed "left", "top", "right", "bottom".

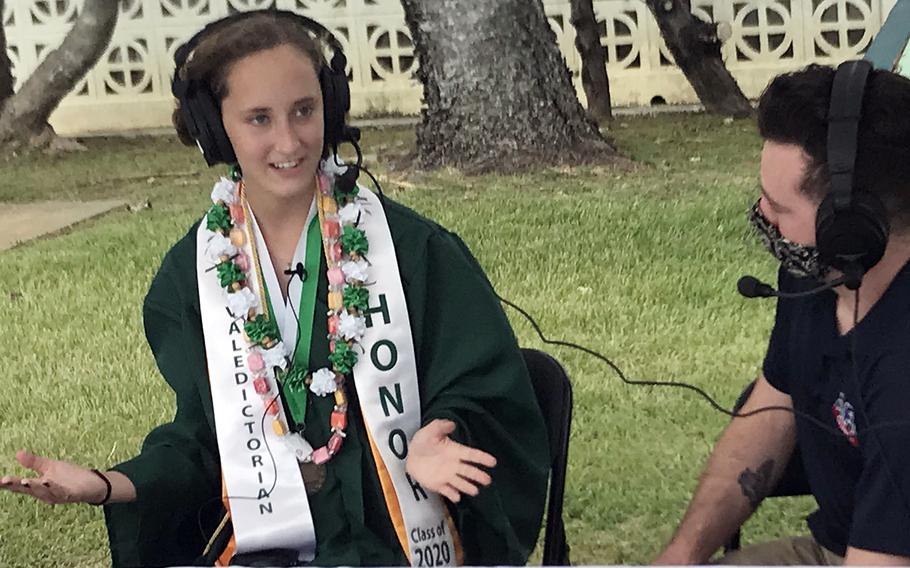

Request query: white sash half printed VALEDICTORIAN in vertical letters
[{"left": 196, "top": 219, "right": 316, "bottom": 562}]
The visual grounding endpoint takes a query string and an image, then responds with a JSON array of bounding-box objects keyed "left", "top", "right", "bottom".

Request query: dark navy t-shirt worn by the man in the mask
[{"left": 764, "top": 264, "right": 910, "bottom": 556}]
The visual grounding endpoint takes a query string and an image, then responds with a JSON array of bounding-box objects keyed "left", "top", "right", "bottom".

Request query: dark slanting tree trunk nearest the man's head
[{"left": 646, "top": 0, "right": 752, "bottom": 117}]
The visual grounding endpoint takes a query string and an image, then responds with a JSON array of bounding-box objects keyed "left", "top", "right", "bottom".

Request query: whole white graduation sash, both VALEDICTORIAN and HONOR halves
[{"left": 196, "top": 184, "right": 462, "bottom": 566}]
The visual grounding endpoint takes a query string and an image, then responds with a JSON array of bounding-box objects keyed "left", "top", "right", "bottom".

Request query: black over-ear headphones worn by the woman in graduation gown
[{"left": 171, "top": 9, "right": 360, "bottom": 166}]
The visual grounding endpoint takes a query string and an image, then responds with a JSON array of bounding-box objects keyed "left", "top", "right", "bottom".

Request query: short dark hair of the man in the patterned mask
[{"left": 758, "top": 65, "right": 910, "bottom": 230}]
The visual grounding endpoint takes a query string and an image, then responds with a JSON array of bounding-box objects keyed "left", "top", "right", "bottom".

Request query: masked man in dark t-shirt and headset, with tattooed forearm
[{"left": 655, "top": 61, "right": 910, "bottom": 565}]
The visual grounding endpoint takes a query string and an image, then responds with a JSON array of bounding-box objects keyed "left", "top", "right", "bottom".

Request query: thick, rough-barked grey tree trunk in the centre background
[{"left": 401, "top": 0, "right": 617, "bottom": 173}]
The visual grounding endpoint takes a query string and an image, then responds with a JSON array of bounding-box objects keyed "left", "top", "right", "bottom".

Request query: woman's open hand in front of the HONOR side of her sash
[{"left": 406, "top": 420, "right": 496, "bottom": 503}]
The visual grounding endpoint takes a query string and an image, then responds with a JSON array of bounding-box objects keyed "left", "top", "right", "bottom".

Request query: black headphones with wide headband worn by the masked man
[{"left": 815, "top": 60, "right": 890, "bottom": 290}]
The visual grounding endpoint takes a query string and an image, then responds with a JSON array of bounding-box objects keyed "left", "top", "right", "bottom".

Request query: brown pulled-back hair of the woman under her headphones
[{"left": 171, "top": 13, "right": 325, "bottom": 146}]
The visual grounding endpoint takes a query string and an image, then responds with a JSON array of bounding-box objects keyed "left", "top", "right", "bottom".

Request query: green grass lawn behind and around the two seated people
[{"left": 0, "top": 115, "right": 812, "bottom": 567}]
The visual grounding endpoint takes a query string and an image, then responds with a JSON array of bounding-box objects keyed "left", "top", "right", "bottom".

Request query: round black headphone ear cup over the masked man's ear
[{"left": 815, "top": 190, "right": 890, "bottom": 272}]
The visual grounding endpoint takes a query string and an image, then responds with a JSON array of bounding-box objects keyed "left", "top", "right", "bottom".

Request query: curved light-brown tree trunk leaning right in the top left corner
[{"left": 0, "top": 0, "right": 119, "bottom": 147}]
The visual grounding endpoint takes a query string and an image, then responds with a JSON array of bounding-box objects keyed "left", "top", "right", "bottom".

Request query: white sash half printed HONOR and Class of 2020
[{"left": 354, "top": 188, "right": 460, "bottom": 566}]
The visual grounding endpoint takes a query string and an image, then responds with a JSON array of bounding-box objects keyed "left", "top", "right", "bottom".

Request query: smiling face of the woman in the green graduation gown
[{"left": 221, "top": 45, "right": 323, "bottom": 201}]
